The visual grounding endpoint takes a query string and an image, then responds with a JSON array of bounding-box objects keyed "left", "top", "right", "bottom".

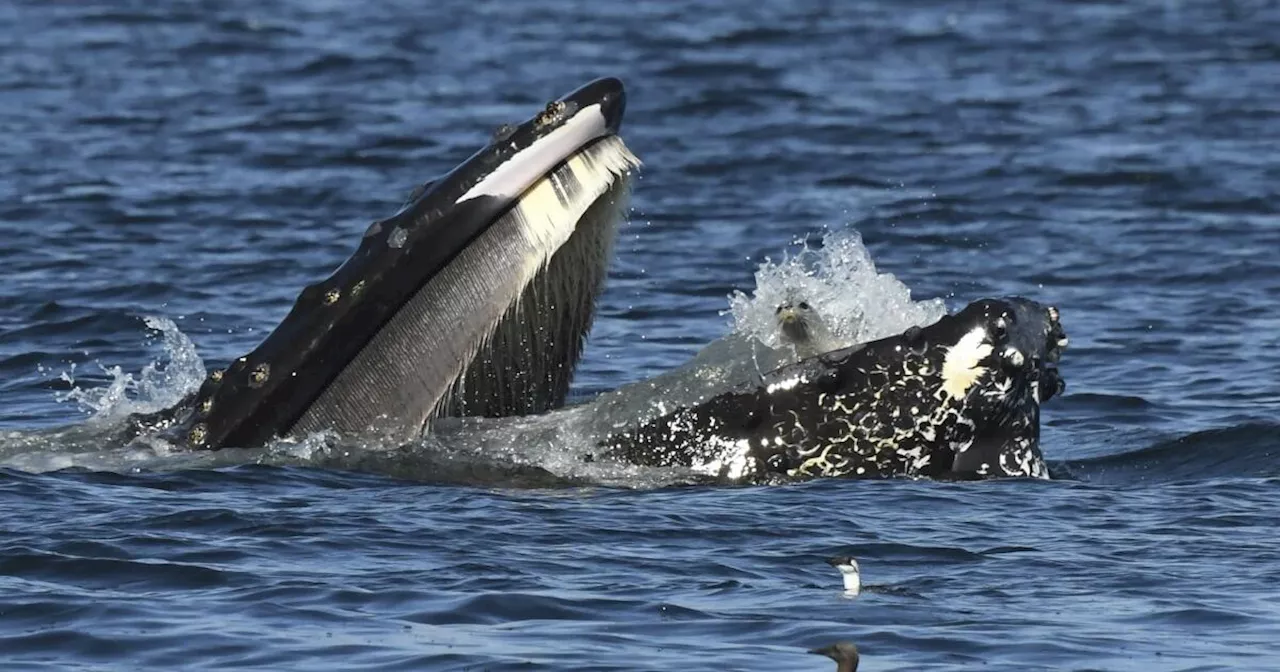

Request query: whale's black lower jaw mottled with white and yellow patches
[{"left": 602, "top": 297, "right": 1066, "bottom": 483}]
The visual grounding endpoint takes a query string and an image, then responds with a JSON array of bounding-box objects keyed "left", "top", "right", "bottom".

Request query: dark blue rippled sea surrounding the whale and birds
[{"left": 0, "top": 0, "right": 1280, "bottom": 671}]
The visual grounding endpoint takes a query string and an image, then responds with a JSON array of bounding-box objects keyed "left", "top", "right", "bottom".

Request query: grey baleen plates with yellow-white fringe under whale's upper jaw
[{"left": 294, "top": 136, "right": 640, "bottom": 439}]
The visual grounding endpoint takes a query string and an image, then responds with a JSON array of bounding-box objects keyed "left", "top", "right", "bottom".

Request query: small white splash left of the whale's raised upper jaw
[{"left": 56, "top": 315, "right": 205, "bottom": 421}]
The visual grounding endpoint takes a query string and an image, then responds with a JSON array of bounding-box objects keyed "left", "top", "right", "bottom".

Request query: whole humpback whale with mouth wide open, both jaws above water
[{"left": 99, "top": 78, "right": 1068, "bottom": 483}]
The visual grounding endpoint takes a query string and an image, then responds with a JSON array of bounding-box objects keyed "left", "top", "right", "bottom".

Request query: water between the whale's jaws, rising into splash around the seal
[{"left": 434, "top": 225, "right": 946, "bottom": 488}]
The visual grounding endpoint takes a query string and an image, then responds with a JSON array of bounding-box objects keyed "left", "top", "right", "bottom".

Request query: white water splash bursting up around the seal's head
[{"left": 728, "top": 230, "right": 946, "bottom": 348}]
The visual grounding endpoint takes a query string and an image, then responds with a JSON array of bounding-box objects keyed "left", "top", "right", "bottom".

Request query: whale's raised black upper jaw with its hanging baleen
[{"left": 133, "top": 78, "right": 640, "bottom": 449}]
